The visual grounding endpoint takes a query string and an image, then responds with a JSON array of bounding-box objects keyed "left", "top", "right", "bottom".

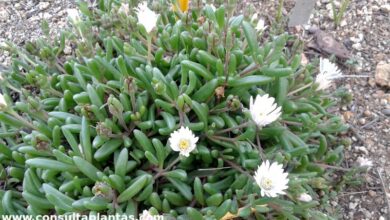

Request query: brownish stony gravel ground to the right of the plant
[{"left": 311, "top": 0, "right": 390, "bottom": 219}]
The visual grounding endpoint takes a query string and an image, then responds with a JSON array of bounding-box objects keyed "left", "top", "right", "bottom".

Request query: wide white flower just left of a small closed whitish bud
[{"left": 254, "top": 160, "right": 288, "bottom": 197}]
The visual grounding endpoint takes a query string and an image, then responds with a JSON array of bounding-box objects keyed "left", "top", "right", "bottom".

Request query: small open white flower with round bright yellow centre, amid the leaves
[{"left": 168, "top": 127, "right": 199, "bottom": 157}]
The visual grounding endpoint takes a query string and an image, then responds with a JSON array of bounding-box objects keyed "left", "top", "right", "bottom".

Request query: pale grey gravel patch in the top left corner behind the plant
[{"left": 0, "top": 0, "right": 76, "bottom": 65}]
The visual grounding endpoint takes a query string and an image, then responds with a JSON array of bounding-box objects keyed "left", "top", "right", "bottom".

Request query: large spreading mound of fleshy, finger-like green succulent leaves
[{"left": 0, "top": 0, "right": 362, "bottom": 219}]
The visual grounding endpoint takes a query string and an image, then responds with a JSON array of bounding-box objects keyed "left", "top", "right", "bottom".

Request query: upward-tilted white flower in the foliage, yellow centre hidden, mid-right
[{"left": 249, "top": 94, "right": 282, "bottom": 127}]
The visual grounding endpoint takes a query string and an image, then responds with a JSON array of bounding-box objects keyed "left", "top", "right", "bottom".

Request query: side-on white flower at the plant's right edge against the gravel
[{"left": 315, "top": 58, "right": 343, "bottom": 90}]
